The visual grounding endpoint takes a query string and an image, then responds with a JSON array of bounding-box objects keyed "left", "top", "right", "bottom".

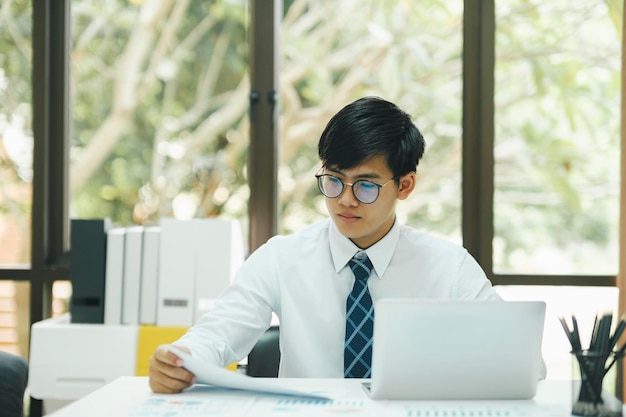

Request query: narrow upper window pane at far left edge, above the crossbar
[{"left": 0, "top": 1, "right": 33, "bottom": 266}]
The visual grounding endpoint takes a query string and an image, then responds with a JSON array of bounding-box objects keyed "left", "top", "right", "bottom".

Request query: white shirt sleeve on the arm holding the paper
[{"left": 174, "top": 240, "right": 278, "bottom": 366}]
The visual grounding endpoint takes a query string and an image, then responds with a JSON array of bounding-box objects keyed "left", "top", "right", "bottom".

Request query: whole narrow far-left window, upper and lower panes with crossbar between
[{"left": 0, "top": 1, "right": 33, "bottom": 357}]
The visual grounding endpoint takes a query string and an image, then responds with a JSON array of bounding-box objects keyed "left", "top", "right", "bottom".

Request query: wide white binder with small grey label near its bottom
[{"left": 157, "top": 218, "right": 196, "bottom": 327}]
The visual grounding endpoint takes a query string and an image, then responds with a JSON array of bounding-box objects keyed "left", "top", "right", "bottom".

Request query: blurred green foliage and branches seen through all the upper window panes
[{"left": 0, "top": 0, "right": 622, "bottom": 269}]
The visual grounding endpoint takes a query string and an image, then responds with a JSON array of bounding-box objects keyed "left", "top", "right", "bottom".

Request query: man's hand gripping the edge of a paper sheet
[{"left": 148, "top": 345, "right": 196, "bottom": 394}]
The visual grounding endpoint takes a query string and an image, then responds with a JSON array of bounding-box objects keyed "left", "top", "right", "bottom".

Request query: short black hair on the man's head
[{"left": 318, "top": 97, "right": 426, "bottom": 177}]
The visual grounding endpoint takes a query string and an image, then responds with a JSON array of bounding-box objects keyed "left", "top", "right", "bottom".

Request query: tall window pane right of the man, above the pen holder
[{"left": 493, "top": 0, "right": 621, "bottom": 276}]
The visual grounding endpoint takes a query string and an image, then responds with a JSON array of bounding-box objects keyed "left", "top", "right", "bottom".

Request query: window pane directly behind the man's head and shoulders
[{"left": 279, "top": 0, "right": 463, "bottom": 243}]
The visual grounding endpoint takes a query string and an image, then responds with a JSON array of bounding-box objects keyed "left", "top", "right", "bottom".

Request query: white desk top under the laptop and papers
[{"left": 50, "top": 377, "right": 571, "bottom": 417}]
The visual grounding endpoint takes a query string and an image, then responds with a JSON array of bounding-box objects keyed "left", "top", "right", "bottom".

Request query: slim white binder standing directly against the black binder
[{"left": 104, "top": 227, "right": 126, "bottom": 325}]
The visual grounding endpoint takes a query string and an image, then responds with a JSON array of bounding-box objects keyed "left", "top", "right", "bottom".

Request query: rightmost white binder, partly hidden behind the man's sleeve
[{"left": 193, "top": 218, "right": 244, "bottom": 322}]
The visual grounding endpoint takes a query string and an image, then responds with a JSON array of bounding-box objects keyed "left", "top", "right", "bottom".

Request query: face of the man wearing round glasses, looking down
[{"left": 323, "top": 156, "right": 415, "bottom": 249}]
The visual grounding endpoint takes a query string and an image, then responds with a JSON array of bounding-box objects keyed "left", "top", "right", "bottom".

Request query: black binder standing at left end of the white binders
[{"left": 70, "top": 218, "right": 111, "bottom": 323}]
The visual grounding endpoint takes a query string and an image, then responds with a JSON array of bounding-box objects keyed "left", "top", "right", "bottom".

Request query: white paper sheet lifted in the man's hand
[{"left": 168, "top": 346, "right": 327, "bottom": 399}]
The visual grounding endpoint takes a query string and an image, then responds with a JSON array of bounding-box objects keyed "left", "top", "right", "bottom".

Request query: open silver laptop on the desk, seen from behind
[{"left": 363, "top": 299, "right": 546, "bottom": 400}]
